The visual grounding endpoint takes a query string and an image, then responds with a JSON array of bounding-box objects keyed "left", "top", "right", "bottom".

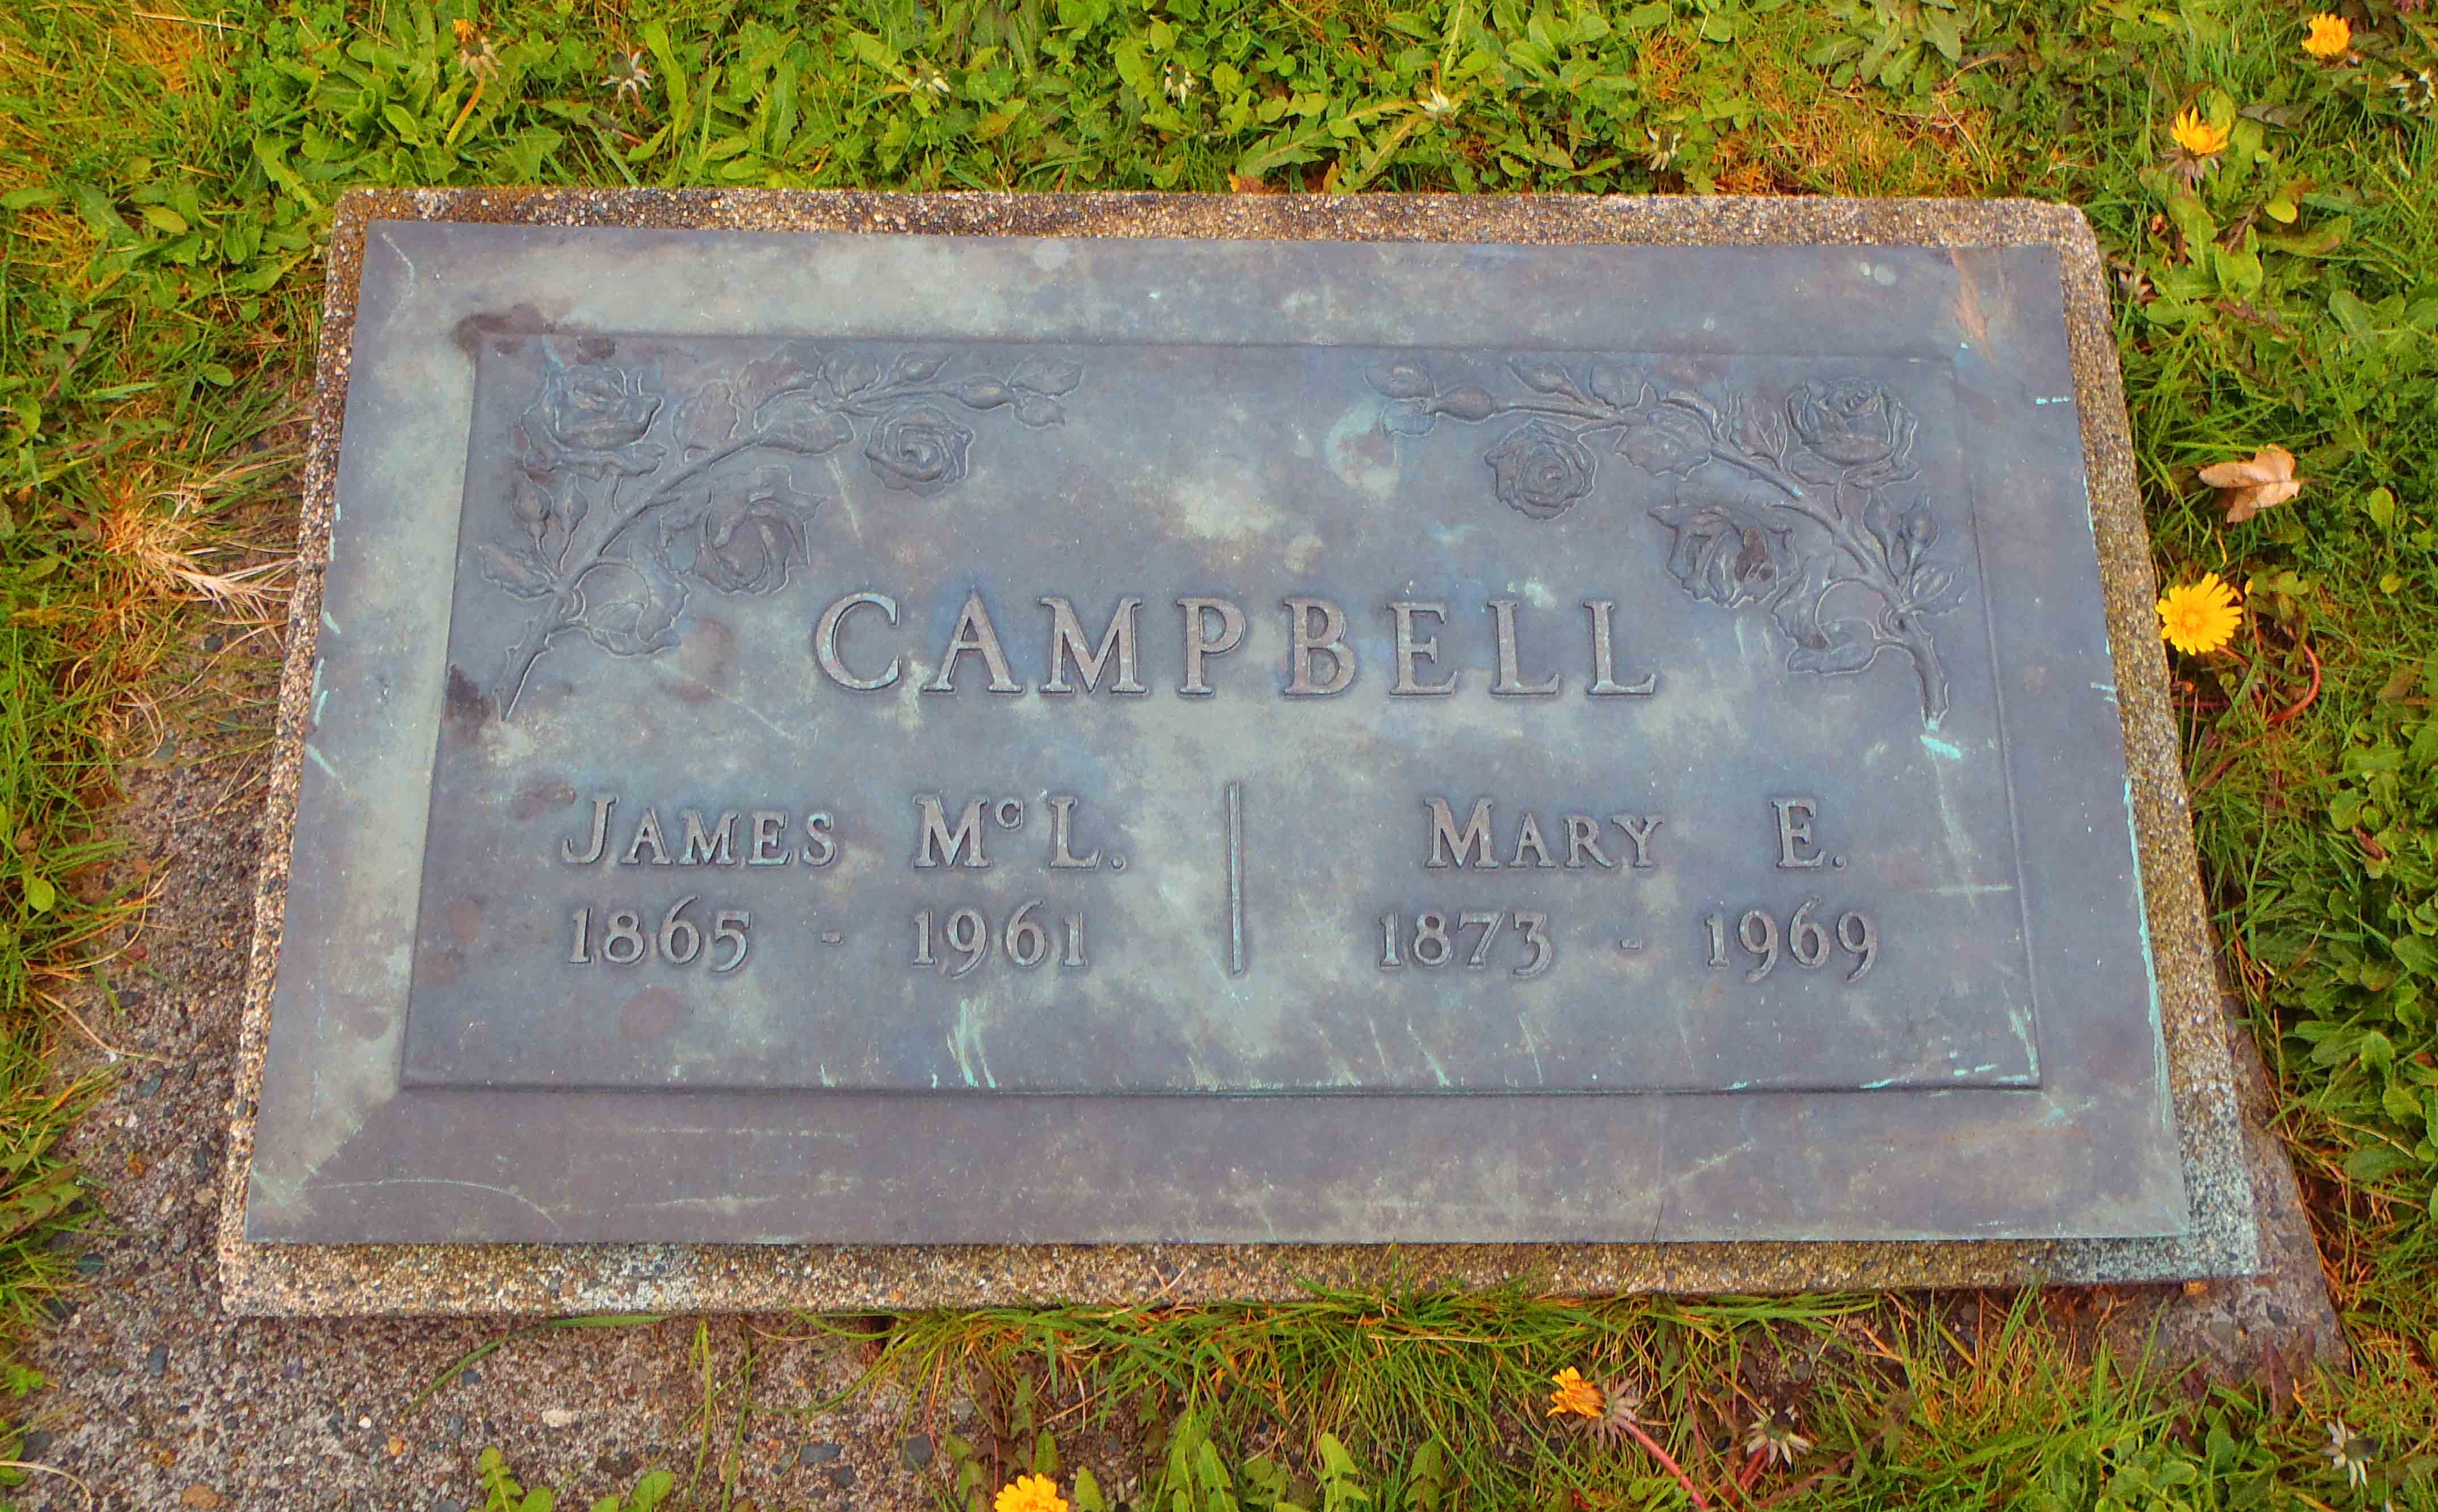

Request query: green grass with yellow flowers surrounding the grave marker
[{"left": 0, "top": 0, "right": 2438, "bottom": 1507}]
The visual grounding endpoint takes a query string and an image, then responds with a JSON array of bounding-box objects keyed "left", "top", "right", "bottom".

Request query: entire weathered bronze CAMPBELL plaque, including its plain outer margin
[{"left": 248, "top": 222, "right": 2187, "bottom": 1241}]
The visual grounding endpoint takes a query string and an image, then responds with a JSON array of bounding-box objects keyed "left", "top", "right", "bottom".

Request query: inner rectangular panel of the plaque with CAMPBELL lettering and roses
[{"left": 405, "top": 327, "right": 2038, "bottom": 1093}]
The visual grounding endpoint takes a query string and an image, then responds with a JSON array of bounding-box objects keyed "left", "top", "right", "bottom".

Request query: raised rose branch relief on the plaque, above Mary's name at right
[{"left": 1370, "top": 359, "right": 1960, "bottom": 729}]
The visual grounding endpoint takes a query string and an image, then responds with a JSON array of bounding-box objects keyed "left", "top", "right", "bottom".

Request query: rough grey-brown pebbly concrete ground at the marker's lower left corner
[{"left": 26, "top": 751, "right": 931, "bottom": 1512}]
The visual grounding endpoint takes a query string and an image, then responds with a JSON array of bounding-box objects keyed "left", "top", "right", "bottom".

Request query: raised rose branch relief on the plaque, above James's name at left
[{"left": 478, "top": 344, "right": 1083, "bottom": 720}]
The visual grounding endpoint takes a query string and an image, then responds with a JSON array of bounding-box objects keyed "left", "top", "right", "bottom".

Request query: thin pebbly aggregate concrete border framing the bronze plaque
[{"left": 219, "top": 190, "right": 2260, "bottom": 1314}]
